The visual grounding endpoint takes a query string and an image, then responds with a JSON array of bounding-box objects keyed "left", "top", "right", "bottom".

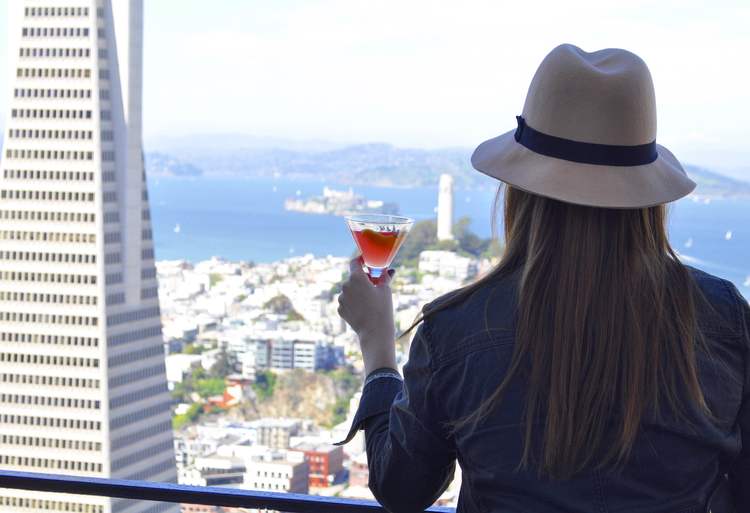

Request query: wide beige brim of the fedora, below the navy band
[{"left": 471, "top": 130, "right": 695, "bottom": 208}]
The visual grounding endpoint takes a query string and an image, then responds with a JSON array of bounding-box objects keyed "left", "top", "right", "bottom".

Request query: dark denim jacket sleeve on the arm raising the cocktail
[{"left": 362, "top": 323, "right": 456, "bottom": 513}]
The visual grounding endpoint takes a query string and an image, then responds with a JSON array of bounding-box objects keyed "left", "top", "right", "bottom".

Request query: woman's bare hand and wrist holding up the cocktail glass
[{"left": 339, "top": 257, "right": 396, "bottom": 375}]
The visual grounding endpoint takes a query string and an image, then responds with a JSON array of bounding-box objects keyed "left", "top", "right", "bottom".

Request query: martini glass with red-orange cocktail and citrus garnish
[{"left": 345, "top": 214, "right": 414, "bottom": 284}]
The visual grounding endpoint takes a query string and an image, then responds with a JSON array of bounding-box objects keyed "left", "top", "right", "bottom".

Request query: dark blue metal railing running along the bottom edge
[{"left": 0, "top": 470, "right": 454, "bottom": 513}]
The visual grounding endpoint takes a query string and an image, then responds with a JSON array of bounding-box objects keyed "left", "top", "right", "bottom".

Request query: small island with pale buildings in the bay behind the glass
[{"left": 284, "top": 187, "right": 398, "bottom": 215}]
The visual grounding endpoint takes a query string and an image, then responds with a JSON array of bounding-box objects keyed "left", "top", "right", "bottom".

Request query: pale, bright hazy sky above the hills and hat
[{"left": 0, "top": 0, "right": 750, "bottom": 174}]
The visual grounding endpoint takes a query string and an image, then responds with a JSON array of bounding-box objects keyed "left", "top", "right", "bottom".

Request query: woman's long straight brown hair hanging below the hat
[{"left": 400, "top": 187, "right": 710, "bottom": 479}]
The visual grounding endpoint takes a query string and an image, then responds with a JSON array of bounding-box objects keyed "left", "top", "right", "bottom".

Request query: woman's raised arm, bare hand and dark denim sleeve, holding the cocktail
[{"left": 339, "top": 259, "right": 456, "bottom": 513}]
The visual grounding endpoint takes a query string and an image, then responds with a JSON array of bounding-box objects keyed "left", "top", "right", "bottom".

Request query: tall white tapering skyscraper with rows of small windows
[{"left": 0, "top": 0, "right": 177, "bottom": 513}]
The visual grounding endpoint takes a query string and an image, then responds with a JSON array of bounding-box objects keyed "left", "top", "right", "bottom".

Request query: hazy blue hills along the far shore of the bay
[{"left": 142, "top": 136, "right": 750, "bottom": 196}]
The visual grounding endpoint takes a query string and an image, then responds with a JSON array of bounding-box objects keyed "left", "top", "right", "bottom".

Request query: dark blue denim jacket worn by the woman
[{"left": 341, "top": 268, "right": 750, "bottom": 513}]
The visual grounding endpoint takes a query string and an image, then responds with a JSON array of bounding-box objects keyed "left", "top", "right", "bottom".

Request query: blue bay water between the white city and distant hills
[{"left": 149, "top": 179, "right": 750, "bottom": 296}]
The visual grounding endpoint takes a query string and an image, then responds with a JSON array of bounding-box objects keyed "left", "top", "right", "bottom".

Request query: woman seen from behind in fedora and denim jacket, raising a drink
[{"left": 339, "top": 45, "right": 750, "bottom": 513}]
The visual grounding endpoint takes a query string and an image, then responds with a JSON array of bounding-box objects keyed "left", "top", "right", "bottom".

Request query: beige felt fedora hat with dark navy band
[{"left": 471, "top": 44, "right": 695, "bottom": 208}]
